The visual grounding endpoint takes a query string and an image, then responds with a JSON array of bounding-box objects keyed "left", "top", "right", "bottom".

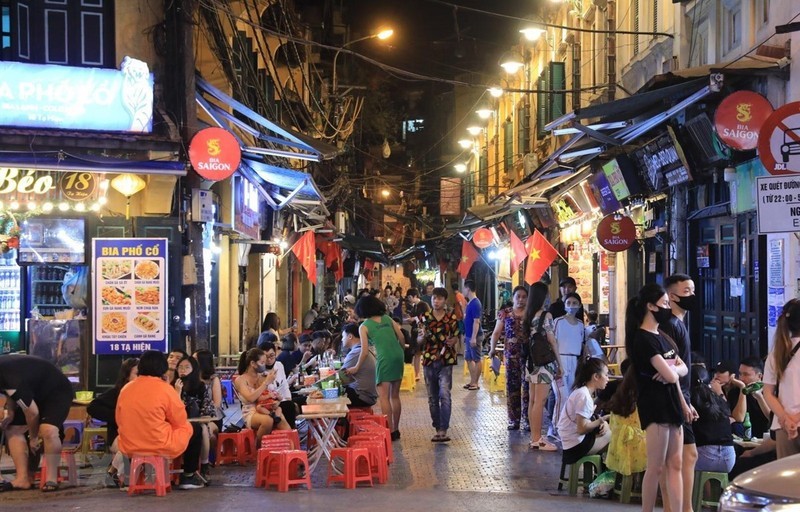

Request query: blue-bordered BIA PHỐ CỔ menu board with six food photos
[{"left": 92, "top": 238, "right": 167, "bottom": 354}]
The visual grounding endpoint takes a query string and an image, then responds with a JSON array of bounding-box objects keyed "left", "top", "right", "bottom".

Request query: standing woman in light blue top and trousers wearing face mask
[{"left": 551, "top": 292, "right": 586, "bottom": 438}]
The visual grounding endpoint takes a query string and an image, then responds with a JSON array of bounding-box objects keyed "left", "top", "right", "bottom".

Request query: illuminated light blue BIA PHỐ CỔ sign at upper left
[{"left": 0, "top": 57, "right": 153, "bottom": 133}]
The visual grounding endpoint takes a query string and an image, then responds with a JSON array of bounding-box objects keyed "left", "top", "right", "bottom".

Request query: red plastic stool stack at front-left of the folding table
[{"left": 255, "top": 430, "right": 311, "bottom": 492}]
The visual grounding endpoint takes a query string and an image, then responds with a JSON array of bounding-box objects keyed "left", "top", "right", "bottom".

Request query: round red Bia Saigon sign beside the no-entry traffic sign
[{"left": 714, "top": 91, "right": 774, "bottom": 151}]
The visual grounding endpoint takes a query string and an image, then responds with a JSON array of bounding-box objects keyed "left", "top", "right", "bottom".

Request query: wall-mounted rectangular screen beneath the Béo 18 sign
[{"left": 19, "top": 217, "right": 86, "bottom": 265}]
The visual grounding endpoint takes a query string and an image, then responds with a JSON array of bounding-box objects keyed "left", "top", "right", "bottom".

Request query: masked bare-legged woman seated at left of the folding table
[{"left": 233, "top": 348, "right": 289, "bottom": 446}]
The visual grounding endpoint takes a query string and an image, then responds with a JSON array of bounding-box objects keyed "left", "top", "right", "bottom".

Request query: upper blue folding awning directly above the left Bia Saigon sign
[{"left": 195, "top": 76, "right": 340, "bottom": 162}]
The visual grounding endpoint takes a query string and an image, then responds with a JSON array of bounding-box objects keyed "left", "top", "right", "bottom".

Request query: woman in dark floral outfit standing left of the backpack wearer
[{"left": 489, "top": 286, "right": 531, "bottom": 430}]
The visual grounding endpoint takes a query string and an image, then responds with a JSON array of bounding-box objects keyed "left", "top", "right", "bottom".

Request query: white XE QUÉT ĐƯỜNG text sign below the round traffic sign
[{"left": 756, "top": 175, "right": 800, "bottom": 234}]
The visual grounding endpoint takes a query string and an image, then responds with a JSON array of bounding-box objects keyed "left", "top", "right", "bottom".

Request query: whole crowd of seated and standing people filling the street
[{"left": 0, "top": 274, "right": 800, "bottom": 504}]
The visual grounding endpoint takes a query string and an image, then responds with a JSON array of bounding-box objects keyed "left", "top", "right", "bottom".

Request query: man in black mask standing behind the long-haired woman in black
[{"left": 657, "top": 274, "right": 698, "bottom": 512}]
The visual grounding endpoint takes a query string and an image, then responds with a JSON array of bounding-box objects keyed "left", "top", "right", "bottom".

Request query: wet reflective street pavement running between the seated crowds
[{"left": 0, "top": 368, "right": 638, "bottom": 512}]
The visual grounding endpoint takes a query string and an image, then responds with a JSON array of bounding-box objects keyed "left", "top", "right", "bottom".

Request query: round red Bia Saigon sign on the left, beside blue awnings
[{"left": 189, "top": 128, "right": 242, "bottom": 181}]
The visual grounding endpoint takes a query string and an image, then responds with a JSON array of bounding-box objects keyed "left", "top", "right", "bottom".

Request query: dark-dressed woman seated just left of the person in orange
[{"left": 86, "top": 357, "right": 139, "bottom": 487}]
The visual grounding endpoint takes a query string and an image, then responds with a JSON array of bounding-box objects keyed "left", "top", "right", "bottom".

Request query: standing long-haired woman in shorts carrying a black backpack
[{"left": 522, "top": 282, "right": 562, "bottom": 452}]
